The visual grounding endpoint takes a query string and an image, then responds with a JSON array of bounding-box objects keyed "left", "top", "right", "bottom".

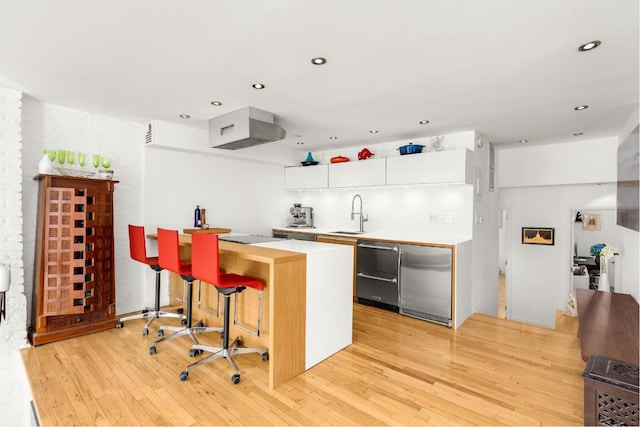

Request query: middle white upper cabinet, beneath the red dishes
[{"left": 329, "top": 159, "right": 386, "bottom": 188}]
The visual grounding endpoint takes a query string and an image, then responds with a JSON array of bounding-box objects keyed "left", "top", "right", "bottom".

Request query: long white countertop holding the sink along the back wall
[{"left": 274, "top": 227, "right": 471, "bottom": 245}]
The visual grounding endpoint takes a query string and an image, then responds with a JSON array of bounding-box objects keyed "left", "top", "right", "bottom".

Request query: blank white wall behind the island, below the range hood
[{"left": 144, "top": 147, "right": 284, "bottom": 235}]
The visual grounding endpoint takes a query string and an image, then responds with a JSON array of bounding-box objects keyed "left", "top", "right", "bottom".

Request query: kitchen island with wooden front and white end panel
[{"left": 148, "top": 234, "right": 353, "bottom": 388}]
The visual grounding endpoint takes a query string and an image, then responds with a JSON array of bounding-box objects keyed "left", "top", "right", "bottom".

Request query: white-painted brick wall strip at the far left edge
[{"left": 0, "top": 89, "right": 27, "bottom": 350}]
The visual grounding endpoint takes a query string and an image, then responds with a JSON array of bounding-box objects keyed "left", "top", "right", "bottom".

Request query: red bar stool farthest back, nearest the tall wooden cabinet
[{"left": 116, "top": 224, "right": 186, "bottom": 335}]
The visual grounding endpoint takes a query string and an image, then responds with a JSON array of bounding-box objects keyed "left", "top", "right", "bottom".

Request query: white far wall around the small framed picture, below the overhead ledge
[{"left": 500, "top": 183, "right": 615, "bottom": 328}]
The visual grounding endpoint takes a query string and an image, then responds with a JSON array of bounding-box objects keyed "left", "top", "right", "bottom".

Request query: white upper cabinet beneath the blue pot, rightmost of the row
[{"left": 386, "top": 149, "right": 473, "bottom": 185}]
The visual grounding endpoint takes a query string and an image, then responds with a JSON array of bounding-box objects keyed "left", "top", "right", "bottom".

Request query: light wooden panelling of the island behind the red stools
[{"left": 148, "top": 234, "right": 306, "bottom": 388}]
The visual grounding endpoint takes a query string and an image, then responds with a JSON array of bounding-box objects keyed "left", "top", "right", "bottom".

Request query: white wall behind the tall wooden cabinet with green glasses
[{"left": 22, "top": 98, "right": 145, "bottom": 318}]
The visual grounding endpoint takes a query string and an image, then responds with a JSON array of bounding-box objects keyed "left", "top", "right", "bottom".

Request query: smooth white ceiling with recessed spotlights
[{"left": 0, "top": 0, "right": 639, "bottom": 151}]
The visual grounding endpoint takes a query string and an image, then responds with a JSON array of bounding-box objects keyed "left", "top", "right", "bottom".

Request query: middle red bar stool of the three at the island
[{"left": 149, "top": 228, "right": 223, "bottom": 357}]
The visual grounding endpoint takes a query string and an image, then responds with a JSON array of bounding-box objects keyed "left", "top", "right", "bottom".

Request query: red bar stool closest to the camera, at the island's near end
[{"left": 180, "top": 233, "right": 269, "bottom": 384}]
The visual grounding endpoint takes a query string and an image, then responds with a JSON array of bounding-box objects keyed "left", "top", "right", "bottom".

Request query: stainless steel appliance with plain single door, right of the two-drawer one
[{"left": 398, "top": 245, "right": 452, "bottom": 326}]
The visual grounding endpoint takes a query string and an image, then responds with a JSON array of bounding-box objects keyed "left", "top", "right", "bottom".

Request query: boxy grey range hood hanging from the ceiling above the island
[{"left": 209, "top": 107, "right": 287, "bottom": 150}]
